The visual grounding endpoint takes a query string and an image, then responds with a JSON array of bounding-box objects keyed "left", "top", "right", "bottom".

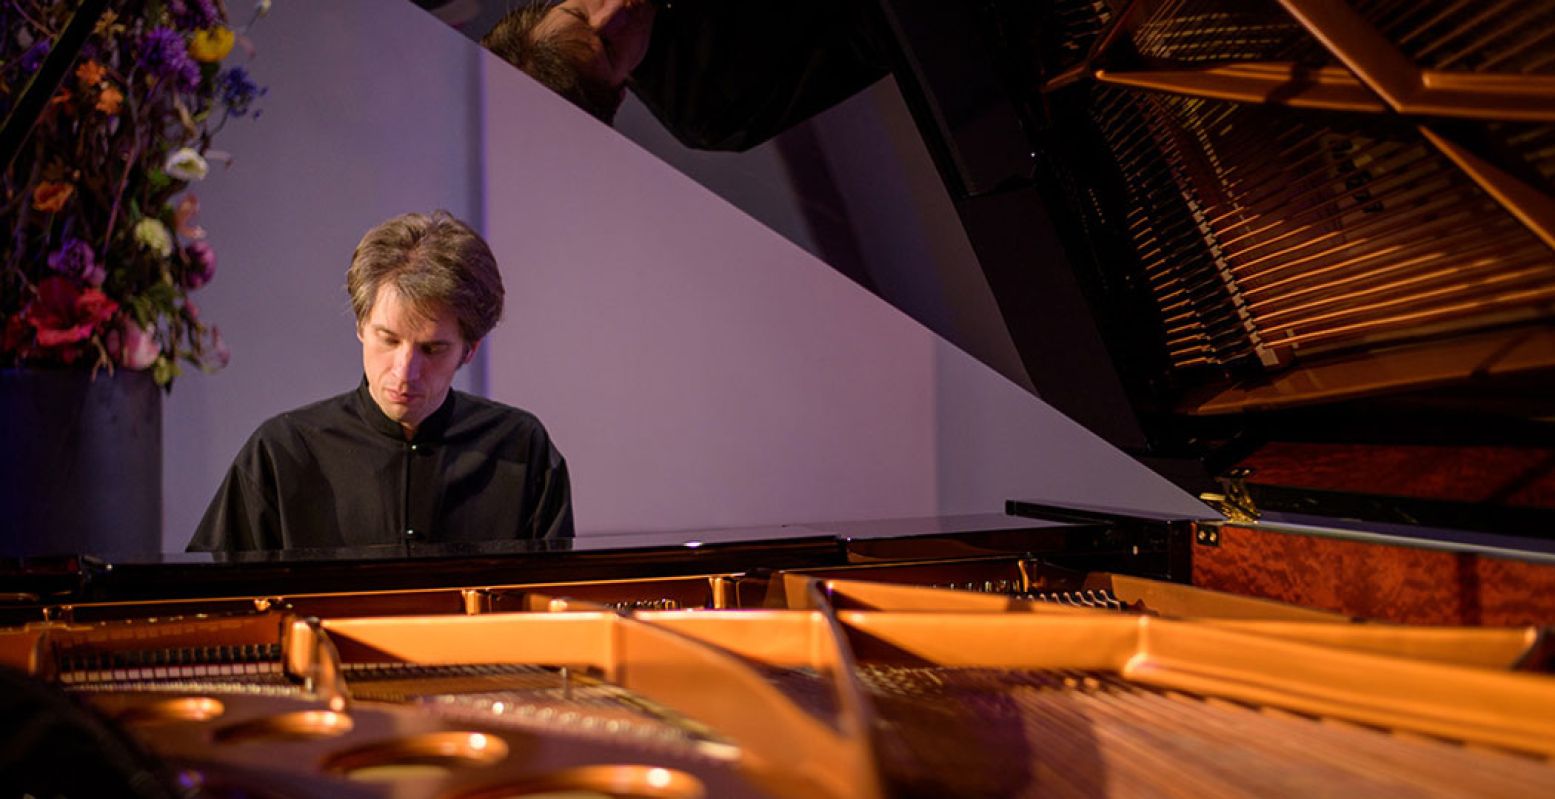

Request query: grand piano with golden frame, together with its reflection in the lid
[{"left": 0, "top": 0, "right": 1555, "bottom": 797}]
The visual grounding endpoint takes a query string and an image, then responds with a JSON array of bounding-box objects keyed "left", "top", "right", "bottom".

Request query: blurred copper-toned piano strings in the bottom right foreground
[{"left": 860, "top": 664, "right": 1555, "bottom": 799}]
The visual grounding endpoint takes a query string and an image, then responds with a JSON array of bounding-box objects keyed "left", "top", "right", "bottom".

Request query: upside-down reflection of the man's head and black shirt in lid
[{"left": 480, "top": 0, "right": 889, "bottom": 149}]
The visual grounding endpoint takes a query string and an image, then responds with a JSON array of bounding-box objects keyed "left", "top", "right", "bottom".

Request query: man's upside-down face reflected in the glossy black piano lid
[{"left": 535, "top": 0, "right": 655, "bottom": 89}]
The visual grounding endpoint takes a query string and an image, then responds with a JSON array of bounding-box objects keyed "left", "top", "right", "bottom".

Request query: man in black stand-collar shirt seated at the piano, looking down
[{"left": 188, "top": 211, "right": 572, "bottom": 552}]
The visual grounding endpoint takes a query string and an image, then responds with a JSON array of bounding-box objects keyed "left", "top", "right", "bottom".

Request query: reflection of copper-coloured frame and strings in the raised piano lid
[{"left": 1033, "top": 0, "right": 1555, "bottom": 413}]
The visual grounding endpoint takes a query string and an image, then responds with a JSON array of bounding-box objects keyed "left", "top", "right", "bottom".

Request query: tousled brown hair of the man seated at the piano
[{"left": 345, "top": 211, "right": 504, "bottom": 344}]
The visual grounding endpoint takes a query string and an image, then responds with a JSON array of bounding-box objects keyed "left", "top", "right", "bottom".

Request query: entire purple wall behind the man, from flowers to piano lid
[{"left": 163, "top": 0, "right": 1202, "bottom": 550}]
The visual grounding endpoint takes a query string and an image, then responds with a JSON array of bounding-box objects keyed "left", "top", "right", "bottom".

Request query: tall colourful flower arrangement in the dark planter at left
[{"left": 0, "top": 0, "right": 269, "bottom": 387}]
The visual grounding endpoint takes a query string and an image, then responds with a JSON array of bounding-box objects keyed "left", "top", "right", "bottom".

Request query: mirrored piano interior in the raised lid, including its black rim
[{"left": 882, "top": 0, "right": 1555, "bottom": 539}]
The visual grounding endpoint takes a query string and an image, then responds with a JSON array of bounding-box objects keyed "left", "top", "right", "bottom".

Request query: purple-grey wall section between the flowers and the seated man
[{"left": 163, "top": 0, "right": 480, "bottom": 550}]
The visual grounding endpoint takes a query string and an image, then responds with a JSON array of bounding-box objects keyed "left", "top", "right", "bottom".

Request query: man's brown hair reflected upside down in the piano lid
[{"left": 480, "top": 0, "right": 620, "bottom": 124}]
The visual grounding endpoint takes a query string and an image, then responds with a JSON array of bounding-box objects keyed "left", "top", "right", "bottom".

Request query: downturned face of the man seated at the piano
[{"left": 356, "top": 283, "right": 480, "bottom": 435}]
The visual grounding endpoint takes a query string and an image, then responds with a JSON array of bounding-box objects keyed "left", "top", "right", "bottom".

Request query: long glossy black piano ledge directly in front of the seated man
[{"left": 0, "top": 515, "right": 1094, "bottom": 608}]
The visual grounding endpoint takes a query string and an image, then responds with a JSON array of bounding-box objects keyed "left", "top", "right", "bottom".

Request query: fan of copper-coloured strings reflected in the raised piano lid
[{"left": 1093, "top": 77, "right": 1555, "bottom": 368}]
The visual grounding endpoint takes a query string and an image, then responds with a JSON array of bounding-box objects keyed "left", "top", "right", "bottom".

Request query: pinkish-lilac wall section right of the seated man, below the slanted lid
[{"left": 482, "top": 56, "right": 1204, "bottom": 533}]
